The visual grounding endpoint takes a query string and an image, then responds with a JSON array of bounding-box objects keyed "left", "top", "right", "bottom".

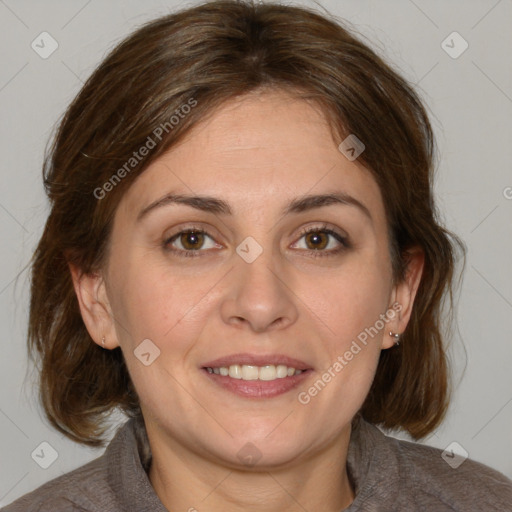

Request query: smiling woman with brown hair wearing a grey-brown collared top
[{"left": 4, "top": 1, "right": 512, "bottom": 512}]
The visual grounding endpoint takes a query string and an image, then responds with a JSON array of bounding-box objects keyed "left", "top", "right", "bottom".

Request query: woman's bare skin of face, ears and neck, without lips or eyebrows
[{"left": 71, "top": 91, "right": 423, "bottom": 512}]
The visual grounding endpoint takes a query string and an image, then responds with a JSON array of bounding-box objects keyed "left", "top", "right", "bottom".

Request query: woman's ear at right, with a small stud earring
[{"left": 382, "top": 246, "right": 425, "bottom": 349}]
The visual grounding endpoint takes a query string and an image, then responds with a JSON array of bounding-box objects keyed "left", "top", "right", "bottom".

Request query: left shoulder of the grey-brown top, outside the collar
[{"left": 0, "top": 456, "right": 112, "bottom": 512}]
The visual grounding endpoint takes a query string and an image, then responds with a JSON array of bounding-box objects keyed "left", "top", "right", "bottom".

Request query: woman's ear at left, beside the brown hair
[{"left": 68, "top": 263, "right": 119, "bottom": 349}]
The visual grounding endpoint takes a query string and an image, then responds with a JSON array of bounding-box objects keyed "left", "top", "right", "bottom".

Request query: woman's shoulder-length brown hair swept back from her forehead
[{"left": 28, "top": 0, "right": 463, "bottom": 446}]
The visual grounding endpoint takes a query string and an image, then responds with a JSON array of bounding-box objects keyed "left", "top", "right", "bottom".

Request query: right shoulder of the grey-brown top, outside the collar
[{"left": 384, "top": 426, "right": 512, "bottom": 512}]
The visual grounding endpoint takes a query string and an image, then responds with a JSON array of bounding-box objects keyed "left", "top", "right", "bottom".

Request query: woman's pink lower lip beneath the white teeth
[{"left": 202, "top": 368, "right": 311, "bottom": 398}]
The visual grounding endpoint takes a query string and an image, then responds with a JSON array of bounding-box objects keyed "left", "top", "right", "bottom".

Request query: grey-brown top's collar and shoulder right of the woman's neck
[{"left": 347, "top": 416, "right": 512, "bottom": 512}]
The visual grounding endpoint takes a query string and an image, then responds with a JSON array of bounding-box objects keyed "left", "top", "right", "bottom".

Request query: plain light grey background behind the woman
[{"left": 0, "top": 0, "right": 512, "bottom": 506}]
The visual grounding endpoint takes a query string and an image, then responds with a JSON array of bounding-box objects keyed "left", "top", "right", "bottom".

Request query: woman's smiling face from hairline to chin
[{"left": 83, "top": 91, "right": 420, "bottom": 466}]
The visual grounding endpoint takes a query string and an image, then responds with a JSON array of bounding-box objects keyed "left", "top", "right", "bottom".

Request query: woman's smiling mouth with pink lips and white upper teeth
[{"left": 201, "top": 354, "right": 313, "bottom": 398}]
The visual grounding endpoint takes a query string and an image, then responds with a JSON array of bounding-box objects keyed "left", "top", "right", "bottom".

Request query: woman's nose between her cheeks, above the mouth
[{"left": 221, "top": 250, "right": 298, "bottom": 332}]
